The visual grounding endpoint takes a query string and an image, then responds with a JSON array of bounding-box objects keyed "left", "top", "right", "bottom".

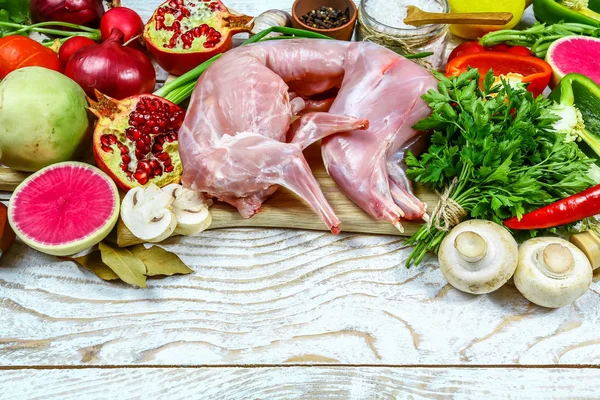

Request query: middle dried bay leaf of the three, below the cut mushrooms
[{"left": 98, "top": 242, "right": 146, "bottom": 288}]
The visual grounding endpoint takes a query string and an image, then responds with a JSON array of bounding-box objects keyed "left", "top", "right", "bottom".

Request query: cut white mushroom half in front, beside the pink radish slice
[{"left": 121, "top": 184, "right": 177, "bottom": 243}]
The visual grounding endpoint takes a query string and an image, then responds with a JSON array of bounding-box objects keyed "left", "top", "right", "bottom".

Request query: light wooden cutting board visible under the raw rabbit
[{"left": 0, "top": 146, "right": 438, "bottom": 247}]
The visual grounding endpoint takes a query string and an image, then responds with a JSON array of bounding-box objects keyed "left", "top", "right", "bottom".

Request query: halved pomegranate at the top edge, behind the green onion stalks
[{"left": 144, "top": 0, "right": 252, "bottom": 75}]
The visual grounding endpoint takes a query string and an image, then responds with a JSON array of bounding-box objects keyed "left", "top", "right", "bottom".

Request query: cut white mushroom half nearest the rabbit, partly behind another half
[{"left": 162, "top": 183, "right": 212, "bottom": 236}]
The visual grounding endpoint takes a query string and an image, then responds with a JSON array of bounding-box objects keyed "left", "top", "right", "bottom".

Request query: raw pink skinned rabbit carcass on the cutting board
[{"left": 179, "top": 39, "right": 435, "bottom": 233}]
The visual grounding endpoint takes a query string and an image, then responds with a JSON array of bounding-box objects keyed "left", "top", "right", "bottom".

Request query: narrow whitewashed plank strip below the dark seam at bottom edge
[{"left": 0, "top": 367, "right": 600, "bottom": 400}]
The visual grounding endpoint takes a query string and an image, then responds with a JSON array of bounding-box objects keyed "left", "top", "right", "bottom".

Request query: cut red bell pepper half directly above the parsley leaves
[{"left": 446, "top": 51, "right": 552, "bottom": 96}]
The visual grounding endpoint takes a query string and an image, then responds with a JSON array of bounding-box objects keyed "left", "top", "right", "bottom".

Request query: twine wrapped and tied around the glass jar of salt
[{"left": 358, "top": 13, "right": 447, "bottom": 69}]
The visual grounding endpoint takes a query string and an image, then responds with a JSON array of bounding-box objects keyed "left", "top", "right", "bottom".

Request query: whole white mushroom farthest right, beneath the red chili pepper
[{"left": 514, "top": 237, "right": 592, "bottom": 308}]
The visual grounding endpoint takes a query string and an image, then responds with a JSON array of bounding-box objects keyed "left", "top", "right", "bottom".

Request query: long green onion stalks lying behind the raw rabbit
[{"left": 154, "top": 26, "right": 433, "bottom": 104}]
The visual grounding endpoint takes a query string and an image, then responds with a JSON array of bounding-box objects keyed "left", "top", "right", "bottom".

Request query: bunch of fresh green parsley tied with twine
[{"left": 406, "top": 69, "right": 595, "bottom": 266}]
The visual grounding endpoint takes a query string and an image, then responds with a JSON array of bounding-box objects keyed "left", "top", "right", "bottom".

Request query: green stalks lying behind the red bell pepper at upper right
[{"left": 479, "top": 22, "right": 600, "bottom": 58}]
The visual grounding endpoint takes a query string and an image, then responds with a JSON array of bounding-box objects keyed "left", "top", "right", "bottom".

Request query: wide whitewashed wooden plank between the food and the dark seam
[{"left": 0, "top": 229, "right": 600, "bottom": 366}]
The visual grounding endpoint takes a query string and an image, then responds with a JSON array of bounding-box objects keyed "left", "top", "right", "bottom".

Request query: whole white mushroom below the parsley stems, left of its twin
[{"left": 438, "top": 220, "right": 518, "bottom": 294}]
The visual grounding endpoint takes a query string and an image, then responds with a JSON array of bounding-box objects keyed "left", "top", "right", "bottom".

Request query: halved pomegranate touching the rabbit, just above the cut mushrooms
[{"left": 90, "top": 92, "right": 185, "bottom": 190}]
